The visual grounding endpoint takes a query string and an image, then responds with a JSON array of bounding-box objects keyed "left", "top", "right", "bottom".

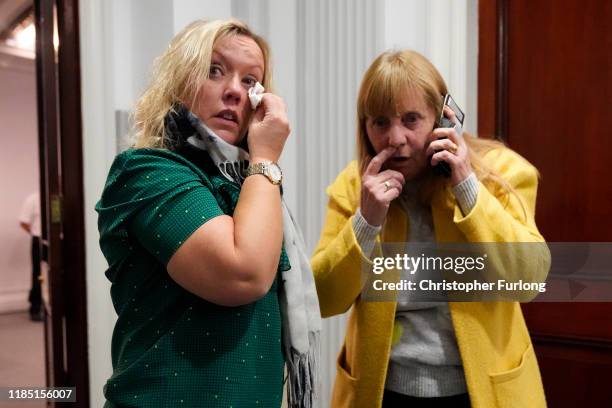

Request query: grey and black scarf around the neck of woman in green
[{"left": 171, "top": 107, "right": 321, "bottom": 408}]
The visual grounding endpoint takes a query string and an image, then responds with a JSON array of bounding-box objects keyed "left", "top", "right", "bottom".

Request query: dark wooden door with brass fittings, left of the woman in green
[{"left": 34, "top": 0, "right": 89, "bottom": 407}]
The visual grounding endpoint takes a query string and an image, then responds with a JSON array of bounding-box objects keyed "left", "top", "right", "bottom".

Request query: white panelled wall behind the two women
[{"left": 81, "top": 0, "right": 477, "bottom": 406}]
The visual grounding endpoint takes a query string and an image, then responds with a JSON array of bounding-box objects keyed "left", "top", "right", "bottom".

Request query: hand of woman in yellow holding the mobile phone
[{"left": 426, "top": 106, "right": 472, "bottom": 186}]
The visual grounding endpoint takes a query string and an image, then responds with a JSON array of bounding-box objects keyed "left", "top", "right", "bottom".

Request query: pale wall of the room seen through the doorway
[{"left": 0, "top": 53, "right": 39, "bottom": 313}]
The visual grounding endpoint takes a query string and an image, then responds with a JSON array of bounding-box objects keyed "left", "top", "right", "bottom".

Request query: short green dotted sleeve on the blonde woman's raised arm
[{"left": 101, "top": 152, "right": 224, "bottom": 265}]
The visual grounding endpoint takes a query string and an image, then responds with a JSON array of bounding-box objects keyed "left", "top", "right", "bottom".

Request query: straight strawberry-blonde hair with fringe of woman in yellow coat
[{"left": 357, "top": 50, "right": 520, "bottom": 212}]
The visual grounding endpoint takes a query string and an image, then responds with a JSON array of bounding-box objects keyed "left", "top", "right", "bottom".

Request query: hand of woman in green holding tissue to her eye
[{"left": 248, "top": 93, "right": 291, "bottom": 162}]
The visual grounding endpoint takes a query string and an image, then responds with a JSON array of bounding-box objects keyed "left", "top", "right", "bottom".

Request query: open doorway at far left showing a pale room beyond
[{"left": 0, "top": 0, "right": 46, "bottom": 407}]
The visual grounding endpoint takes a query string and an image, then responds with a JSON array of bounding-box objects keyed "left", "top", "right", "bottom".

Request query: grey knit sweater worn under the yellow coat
[{"left": 353, "top": 174, "right": 479, "bottom": 397}]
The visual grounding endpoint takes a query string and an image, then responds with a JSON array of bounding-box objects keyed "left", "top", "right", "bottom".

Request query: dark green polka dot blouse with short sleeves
[{"left": 96, "top": 149, "right": 289, "bottom": 408}]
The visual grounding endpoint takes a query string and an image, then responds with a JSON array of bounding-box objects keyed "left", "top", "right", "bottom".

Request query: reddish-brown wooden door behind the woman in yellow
[{"left": 478, "top": 0, "right": 612, "bottom": 408}]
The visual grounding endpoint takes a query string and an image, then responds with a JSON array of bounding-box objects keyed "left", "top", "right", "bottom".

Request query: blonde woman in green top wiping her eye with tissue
[{"left": 96, "top": 20, "right": 320, "bottom": 408}]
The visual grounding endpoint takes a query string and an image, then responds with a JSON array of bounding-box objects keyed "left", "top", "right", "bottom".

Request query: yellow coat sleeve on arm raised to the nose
[{"left": 312, "top": 163, "right": 371, "bottom": 317}]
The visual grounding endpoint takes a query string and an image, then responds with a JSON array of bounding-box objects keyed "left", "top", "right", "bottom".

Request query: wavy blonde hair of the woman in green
[{"left": 133, "top": 19, "right": 272, "bottom": 148}]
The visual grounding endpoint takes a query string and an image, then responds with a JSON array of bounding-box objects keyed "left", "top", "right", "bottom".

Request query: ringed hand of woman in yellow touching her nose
[{"left": 360, "top": 147, "right": 404, "bottom": 226}]
